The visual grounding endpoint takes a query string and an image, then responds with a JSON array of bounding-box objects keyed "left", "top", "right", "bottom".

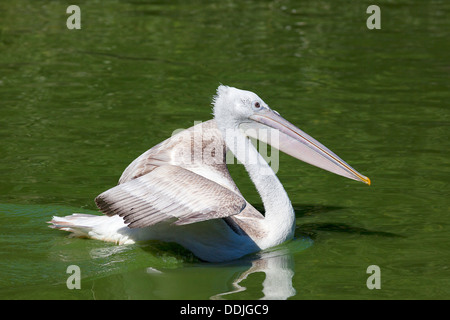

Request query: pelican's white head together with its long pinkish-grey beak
[{"left": 213, "top": 85, "right": 370, "bottom": 185}]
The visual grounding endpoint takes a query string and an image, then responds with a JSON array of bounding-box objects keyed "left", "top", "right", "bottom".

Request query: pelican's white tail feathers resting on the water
[{"left": 48, "top": 213, "right": 134, "bottom": 244}]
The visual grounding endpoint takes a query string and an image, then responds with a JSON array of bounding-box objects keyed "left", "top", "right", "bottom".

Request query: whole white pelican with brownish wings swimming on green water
[{"left": 50, "top": 85, "right": 370, "bottom": 262}]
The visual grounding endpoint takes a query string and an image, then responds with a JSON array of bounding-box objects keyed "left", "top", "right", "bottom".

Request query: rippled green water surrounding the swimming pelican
[{"left": 0, "top": 0, "right": 450, "bottom": 299}]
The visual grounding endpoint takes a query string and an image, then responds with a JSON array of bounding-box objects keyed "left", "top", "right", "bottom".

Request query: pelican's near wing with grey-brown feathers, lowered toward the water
[{"left": 95, "top": 165, "right": 246, "bottom": 228}]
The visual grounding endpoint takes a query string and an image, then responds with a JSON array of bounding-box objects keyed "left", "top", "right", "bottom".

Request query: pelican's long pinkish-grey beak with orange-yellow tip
[{"left": 243, "top": 109, "right": 370, "bottom": 185}]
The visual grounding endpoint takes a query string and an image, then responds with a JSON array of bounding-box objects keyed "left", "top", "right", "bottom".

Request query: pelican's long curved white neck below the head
[{"left": 225, "top": 128, "right": 295, "bottom": 249}]
